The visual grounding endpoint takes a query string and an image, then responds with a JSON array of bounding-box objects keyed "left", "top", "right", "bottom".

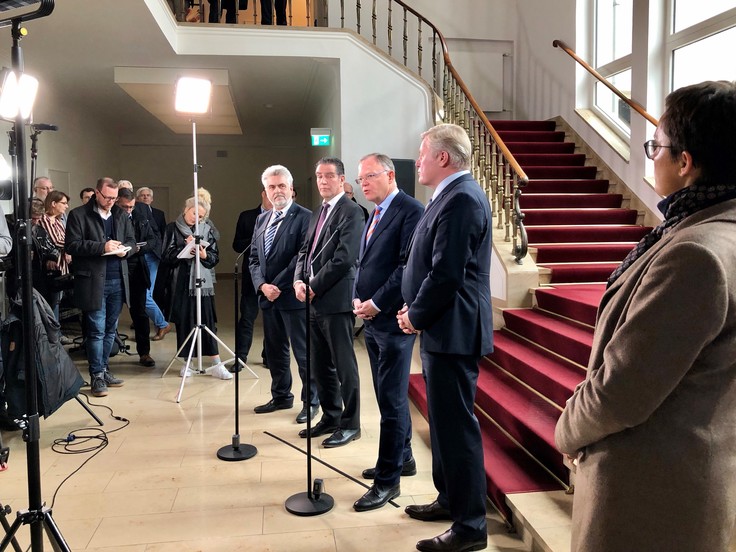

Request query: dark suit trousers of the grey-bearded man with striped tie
[{"left": 263, "top": 307, "right": 319, "bottom": 406}]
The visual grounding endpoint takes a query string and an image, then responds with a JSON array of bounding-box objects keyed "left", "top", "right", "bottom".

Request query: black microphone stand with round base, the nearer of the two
[{"left": 284, "top": 274, "right": 335, "bottom": 516}]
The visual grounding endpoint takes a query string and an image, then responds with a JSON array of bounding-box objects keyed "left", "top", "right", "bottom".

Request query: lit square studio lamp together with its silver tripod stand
[{"left": 161, "top": 77, "right": 258, "bottom": 404}]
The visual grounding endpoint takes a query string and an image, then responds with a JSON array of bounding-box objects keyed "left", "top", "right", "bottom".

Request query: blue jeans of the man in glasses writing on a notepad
[{"left": 84, "top": 280, "right": 123, "bottom": 376}]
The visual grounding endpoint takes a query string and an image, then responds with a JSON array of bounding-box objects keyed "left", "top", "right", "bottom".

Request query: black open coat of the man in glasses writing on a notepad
[{"left": 64, "top": 198, "right": 136, "bottom": 311}]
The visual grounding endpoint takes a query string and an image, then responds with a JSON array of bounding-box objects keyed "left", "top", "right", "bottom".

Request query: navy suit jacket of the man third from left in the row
[{"left": 354, "top": 191, "right": 424, "bottom": 333}]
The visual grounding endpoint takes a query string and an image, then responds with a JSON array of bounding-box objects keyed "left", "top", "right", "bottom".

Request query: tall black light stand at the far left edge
[{"left": 0, "top": 0, "right": 71, "bottom": 552}]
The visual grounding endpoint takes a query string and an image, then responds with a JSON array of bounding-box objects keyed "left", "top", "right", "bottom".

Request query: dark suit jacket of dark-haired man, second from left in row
[{"left": 294, "top": 195, "right": 364, "bottom": 314}]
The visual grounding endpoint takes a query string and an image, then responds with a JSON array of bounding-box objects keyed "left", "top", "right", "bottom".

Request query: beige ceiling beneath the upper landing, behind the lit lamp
[{"left": 0, "top": 0, "right": 324, "bottom": 140}]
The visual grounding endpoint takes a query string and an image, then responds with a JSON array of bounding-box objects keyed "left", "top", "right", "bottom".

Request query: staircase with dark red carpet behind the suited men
[{"left": 409, "top": 121, "right": 650, "bottom": 520}]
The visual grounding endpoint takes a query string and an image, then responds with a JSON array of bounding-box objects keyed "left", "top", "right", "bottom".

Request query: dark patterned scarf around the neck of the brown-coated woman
[{"left": 606, "top": 182, "right": 736, "bottom": 288}]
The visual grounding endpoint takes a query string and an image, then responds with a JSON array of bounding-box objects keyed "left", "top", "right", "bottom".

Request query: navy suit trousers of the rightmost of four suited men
[{"left": 421, "top": 349, "right": 486, "bottom": 537}]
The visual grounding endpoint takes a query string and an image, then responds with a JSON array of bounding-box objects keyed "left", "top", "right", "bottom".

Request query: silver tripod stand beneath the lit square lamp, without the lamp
[{"left": 161, "top": 119, "right": 258, "bottom": 403}]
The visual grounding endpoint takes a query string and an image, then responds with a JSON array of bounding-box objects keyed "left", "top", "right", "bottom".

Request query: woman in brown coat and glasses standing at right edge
[{"left": 555, "top": 82, "right": 736, "bottom": 552}]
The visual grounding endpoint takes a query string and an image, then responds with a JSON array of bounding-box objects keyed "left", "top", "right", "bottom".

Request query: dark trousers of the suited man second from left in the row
[{"left": 310, "top": 309, "right": 360, "bottom": 429}]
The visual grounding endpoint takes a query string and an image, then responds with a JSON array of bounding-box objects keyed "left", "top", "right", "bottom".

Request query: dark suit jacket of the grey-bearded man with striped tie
[{"left": 250, "top": 202, "right": 312, "bottom": 310}]
